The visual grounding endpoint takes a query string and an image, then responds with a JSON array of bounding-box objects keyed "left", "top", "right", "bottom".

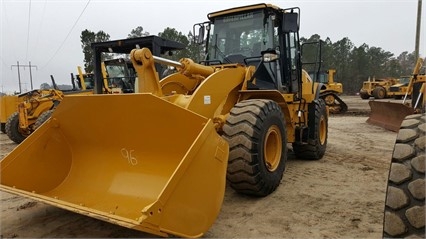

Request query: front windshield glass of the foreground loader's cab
[{"left": 207, "top": 10, "right": 274, "bottom": 63}]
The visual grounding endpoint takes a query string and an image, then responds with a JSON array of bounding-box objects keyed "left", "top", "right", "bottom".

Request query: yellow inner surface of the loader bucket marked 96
[{"left": 1, "top": 94, "right": 207, "bottom": 220}]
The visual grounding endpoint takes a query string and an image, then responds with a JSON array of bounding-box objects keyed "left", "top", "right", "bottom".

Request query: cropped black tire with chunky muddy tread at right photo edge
[{"left": 383, "top": 114, "right": 426, "bottom": 238}]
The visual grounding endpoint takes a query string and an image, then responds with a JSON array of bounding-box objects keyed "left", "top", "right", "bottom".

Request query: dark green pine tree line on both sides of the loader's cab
[{"left": 80, "top": 26, "right": 417, "bottom": 94}]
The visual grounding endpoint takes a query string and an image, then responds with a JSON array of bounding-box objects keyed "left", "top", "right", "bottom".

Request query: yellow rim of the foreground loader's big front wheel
[{"left": 263, "top": 125, "right": 282, "bottom": 172}]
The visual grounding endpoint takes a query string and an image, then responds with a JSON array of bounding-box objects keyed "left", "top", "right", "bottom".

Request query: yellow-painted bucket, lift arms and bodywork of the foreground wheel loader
[{"left": 0, "top": 4, "right": 328, "bottom": 237}]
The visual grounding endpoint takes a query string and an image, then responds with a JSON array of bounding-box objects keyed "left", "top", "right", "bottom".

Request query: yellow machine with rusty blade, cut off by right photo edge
[{"left": 367, "top": 58, "right": 426, "bottom": 132}]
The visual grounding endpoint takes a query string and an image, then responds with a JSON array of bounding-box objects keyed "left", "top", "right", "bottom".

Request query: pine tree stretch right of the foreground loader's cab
[{"left": 300, "top": 34, "right": 417, "bottom": 94}]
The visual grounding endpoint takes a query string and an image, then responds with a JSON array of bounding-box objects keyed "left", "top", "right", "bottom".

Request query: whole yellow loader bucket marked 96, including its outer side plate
[{"left": 0, "top": 94, "right": 229, "bottom": 237}]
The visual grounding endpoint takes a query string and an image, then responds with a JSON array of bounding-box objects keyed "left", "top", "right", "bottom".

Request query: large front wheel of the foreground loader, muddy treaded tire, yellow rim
[{"left": 223, "top": 99, "right": 288, "bottom": 197}]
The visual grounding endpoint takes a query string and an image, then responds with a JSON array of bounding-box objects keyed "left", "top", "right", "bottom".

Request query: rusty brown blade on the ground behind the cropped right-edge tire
[{"left": 367, "top": 100, "right": 414, "bottom": 132}]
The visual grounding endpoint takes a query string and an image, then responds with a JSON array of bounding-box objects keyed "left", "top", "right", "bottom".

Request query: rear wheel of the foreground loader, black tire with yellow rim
[{"left": 292, "top": 99, "right": 328, "bottom": 160}]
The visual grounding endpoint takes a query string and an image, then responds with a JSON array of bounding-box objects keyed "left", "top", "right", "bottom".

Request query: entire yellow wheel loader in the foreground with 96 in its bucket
[{"left": 0, "top": 4, "right": 329, "bottom": 237}]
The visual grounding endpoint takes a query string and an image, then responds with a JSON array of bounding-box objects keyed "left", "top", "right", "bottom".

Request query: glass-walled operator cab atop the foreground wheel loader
[{"left": 194, "top": 4, "right": 301, "bottom": 93}]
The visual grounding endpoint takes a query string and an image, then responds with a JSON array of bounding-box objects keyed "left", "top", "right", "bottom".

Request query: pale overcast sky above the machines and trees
[{"left": 0, "top": 0, "right": 426, "bottom": 92}]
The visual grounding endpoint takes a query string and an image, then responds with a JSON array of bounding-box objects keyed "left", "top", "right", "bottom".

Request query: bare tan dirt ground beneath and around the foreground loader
[{"left": 0, "top": 96, "right": 396, "bottom": 238}]
